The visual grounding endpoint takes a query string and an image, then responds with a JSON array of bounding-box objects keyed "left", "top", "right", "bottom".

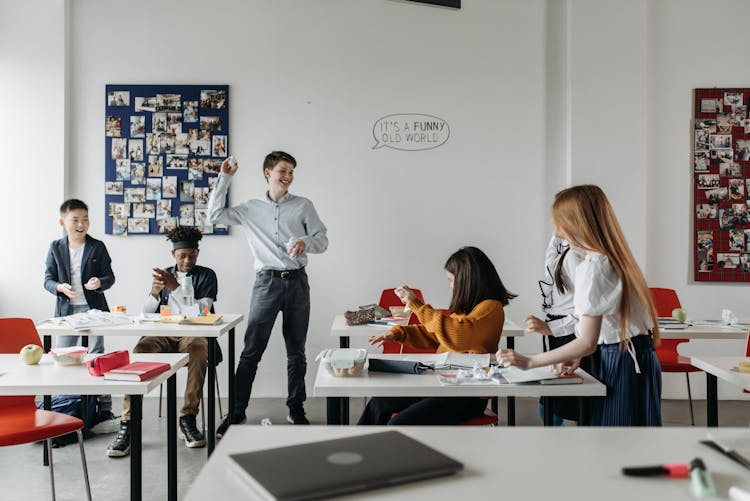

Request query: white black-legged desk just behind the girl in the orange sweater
[{"left": 328, "top": 315, "right": 524, "bottom": 425}]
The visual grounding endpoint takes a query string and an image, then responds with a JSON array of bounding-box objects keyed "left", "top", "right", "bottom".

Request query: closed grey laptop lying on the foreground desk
[{"left": 229, "top": 431, "right": 463, "bottom": 500}]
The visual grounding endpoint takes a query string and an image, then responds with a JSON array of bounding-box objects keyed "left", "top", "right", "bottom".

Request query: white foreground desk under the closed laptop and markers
[{"left": 185, "top": 425, "right": 750, "bottom": 501}]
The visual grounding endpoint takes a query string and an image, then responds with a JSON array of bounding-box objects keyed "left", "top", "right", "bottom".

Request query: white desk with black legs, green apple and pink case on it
[{"left": 0, "top": 353, "right": 189, "bottom": 501}]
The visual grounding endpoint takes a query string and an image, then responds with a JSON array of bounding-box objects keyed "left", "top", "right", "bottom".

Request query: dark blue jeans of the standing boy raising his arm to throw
[{"left": 232, "top": 270, "right": 310, "bottom": 421}]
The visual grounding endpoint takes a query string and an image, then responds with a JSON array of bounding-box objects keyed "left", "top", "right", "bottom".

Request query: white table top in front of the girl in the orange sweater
[{"left": 313, "top": 354, "right": 607, "bottom": 397}]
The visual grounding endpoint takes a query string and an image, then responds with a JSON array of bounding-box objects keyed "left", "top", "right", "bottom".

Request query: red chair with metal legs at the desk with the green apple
[{"left": 0, "top": 318, "right": 91, "bottom": 501}]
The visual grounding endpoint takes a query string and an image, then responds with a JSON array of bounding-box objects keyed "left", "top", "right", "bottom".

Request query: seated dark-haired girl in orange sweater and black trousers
[{"left": 357, "top": 247, "right": 516, "bottom": 425}]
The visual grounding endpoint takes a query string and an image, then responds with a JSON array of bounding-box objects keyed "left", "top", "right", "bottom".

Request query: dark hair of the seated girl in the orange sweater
[{"left": 445, "top": 247, "right": 516, "bottom": 314}]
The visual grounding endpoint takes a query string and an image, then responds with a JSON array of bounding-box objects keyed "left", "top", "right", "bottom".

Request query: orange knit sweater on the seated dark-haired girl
[{"left": 391, "top": 299, "right": 505, "bottom": 353}]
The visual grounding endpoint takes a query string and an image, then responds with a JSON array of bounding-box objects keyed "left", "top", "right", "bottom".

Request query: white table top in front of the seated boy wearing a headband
[{"left": 36, "top": 313, "right": 243, "bottom": 337}]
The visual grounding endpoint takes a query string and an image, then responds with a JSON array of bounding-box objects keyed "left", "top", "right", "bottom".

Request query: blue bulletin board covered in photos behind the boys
[{"left": 104, "top": 85, "right": 229, "bottom": 236}]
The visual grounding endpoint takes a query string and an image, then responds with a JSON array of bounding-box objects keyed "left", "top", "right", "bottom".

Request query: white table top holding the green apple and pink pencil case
[{"left": 0, "top": 353, "right": 190, "bottom": 395}]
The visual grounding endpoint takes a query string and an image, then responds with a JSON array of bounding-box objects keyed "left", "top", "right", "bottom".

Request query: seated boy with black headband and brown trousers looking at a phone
[{"left": 107, "top": 226, "right": 218, "bottom": 457}]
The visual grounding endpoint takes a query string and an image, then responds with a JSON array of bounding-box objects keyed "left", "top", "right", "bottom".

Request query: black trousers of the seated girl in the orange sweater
[{"left": 357, "top": 397, "right": 487, "bottom": 425}]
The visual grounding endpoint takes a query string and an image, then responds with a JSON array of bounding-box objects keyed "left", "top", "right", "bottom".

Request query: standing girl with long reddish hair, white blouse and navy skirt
[{"left": 496, "top": 185, "right": 661, "bottom": 426}]
